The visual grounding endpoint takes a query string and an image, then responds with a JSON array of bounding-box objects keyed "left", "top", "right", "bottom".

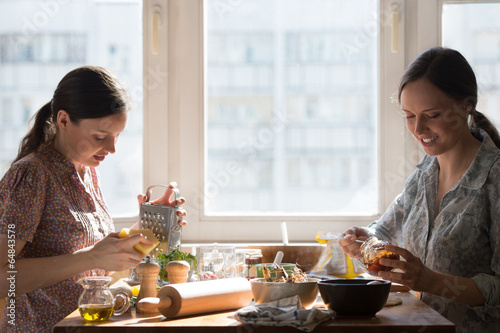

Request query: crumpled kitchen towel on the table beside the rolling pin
[{"left": 234, "top": 296, "right": 334, "bottom": 332}]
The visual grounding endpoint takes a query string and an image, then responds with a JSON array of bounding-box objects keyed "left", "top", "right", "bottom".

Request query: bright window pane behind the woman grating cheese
[{"left": 0, "top": 0, "right": 142, "bottom": 216}]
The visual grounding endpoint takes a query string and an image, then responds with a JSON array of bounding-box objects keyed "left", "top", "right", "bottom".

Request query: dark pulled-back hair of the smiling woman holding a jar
[{"left": 398, "top": 47, "right": 500, "bottom": 148}]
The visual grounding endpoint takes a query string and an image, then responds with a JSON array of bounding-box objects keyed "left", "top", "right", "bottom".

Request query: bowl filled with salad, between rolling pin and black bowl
[{"left": 250, "top": 279, "right": 319, "bottom": 308}]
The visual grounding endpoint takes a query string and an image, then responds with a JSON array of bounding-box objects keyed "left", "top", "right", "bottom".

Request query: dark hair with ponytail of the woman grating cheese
[{"left": 13, "top": 66, "right": 130, "bottom": 163}]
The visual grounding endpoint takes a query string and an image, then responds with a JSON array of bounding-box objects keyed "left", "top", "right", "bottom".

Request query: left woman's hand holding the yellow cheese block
[{"left": 88, "top": 232, "right": 151, "bottom": 271}]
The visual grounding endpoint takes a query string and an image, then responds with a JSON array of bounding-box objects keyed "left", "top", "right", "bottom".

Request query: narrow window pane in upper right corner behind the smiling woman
[{"left": 443, "top": 3, "right": 500, "bottom": 128}]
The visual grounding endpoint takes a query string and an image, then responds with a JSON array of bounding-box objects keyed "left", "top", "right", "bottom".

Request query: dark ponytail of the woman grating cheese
[{"left": 12, "top": 102, "right": 55, "bottom": 163}]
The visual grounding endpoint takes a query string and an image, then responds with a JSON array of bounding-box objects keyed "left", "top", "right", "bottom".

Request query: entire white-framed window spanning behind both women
[{"left": 4, "top": 0, "right": 488, "bottom": 243}]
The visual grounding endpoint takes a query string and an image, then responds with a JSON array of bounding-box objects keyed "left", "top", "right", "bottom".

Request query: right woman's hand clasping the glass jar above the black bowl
[{"left": 378, "top": 244, "right": 436, "bottom": 291}]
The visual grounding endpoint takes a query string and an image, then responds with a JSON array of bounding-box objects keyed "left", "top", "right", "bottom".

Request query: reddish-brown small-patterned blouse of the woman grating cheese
[{"left": 0, "top": 146, "right": 114, "bottom": 333}]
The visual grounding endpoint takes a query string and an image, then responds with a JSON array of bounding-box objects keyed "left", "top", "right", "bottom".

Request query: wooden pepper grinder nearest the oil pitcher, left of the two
[{"left": 135, "top": 256, "right": 160, "bottom": 314}]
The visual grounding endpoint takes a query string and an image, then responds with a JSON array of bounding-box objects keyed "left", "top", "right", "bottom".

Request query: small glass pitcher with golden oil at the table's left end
[{"left": 78, "top": 276, "right": 130, "bottom": 321}]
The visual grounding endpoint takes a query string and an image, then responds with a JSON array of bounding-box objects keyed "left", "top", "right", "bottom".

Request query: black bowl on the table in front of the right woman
[{"left": 318, "top": 279, "right": 391, "bottom": 316}]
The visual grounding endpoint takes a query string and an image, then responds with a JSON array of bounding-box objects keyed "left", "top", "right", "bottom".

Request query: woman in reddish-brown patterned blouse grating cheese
[{"left": 0, "top": 66, "right": 187, "bottom": 333}]
